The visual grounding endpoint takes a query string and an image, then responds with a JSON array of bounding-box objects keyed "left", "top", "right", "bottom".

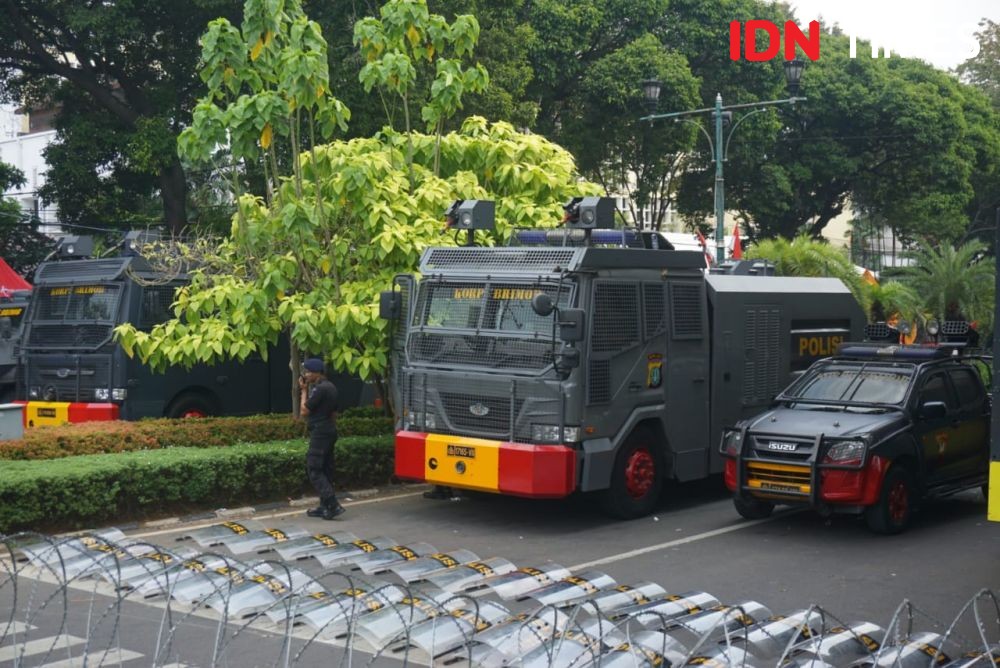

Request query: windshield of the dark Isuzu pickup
[{"left": 782, "top": 364, "right": 911, "bottom": 405}]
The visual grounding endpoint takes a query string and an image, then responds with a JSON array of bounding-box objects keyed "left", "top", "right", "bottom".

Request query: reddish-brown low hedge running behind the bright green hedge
[{"left": 0, "top": 410, "right": 392, "bottom": 460}]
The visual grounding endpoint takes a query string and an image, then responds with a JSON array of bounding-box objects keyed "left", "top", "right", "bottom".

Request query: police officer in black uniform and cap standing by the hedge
[{"left": 299, "top": 357, "right": 344, "bottom": 520}]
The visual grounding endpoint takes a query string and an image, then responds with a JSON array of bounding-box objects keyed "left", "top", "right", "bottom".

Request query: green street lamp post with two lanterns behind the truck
[{"left": 639, "top": 58, "right": 806, "bottom": 263}]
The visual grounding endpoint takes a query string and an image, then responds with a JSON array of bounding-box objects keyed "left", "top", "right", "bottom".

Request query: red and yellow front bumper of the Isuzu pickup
[{"left": 724, "top": 455, "right": 889, "bottom": 508}]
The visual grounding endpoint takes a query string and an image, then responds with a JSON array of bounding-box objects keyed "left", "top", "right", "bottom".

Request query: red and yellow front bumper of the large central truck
[{"left": 396, "top": 431, "right": 576, "bottom": 498}]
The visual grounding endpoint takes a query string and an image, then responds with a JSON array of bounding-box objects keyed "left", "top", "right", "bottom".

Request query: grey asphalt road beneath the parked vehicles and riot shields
[{"left": 0, "top": 480, "right": 1000, "bottom": 668}]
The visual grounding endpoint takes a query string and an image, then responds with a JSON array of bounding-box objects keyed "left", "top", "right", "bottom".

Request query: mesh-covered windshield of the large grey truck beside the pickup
[{"left": 408, "top": 280, "right": 573, "bottom": 371}]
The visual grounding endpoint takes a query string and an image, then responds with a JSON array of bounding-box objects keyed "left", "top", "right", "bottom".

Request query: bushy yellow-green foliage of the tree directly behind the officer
[{"left": 117, "top": 117, "right": 600, "bottom": 412}]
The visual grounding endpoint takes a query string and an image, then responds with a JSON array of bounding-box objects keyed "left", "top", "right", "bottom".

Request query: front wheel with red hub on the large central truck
[{"left": 603, "top": 430, "right": 665, "bottom": 520}]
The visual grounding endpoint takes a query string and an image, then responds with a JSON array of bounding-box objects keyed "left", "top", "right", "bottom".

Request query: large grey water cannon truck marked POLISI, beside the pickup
[{"left": 380, "top": 197, "right": 865, "bottom": 518}]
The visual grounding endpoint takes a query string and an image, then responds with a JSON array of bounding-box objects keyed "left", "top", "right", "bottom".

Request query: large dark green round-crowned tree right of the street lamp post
[{"left": 680, "top": 32, "right": 1000, "bottom": 248}]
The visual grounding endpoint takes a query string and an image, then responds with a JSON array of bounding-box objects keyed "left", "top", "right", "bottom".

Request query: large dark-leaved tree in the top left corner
[{"left": 0, "top": 0, "right": 242, "bottom": 230}]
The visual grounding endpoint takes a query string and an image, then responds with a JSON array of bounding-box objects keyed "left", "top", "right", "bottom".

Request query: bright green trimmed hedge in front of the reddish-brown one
[{"left": 0, "top": 436, "right": 393, "bottom": 533}]
